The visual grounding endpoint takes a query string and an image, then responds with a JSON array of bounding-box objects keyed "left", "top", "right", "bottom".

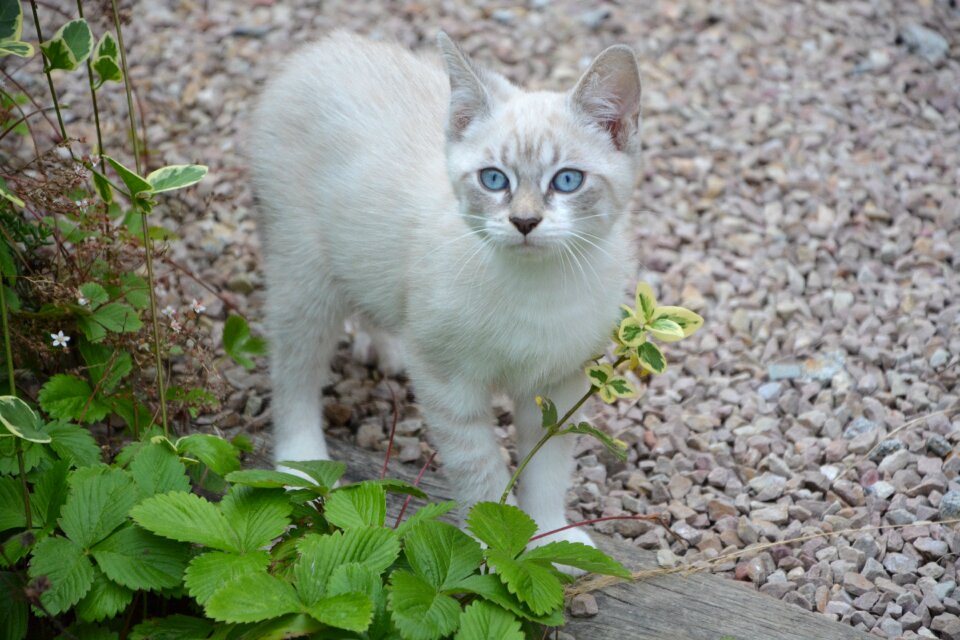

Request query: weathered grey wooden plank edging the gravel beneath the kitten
[{"left": 329, "top": 441, "right": 873, "bottom": 640}]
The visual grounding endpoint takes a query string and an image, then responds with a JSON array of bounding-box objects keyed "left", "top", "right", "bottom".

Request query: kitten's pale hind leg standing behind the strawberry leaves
[{"left": 266, "top": 270, "right": 346, "bottom": 462}]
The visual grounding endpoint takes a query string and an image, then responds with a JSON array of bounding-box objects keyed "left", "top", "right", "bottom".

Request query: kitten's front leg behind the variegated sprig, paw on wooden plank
[{"left": 513, "top": 371, "right": 595, "bottom": 546}]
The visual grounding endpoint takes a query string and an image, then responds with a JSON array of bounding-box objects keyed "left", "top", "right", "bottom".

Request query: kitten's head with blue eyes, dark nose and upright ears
[{"left": 438, "top": 33, "right": 640, "bottom": 255}]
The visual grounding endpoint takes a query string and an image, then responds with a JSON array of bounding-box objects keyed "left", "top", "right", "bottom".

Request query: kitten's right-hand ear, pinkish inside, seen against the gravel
[{"left": 570, "top": 44, "right": 640, "bottom": 151}]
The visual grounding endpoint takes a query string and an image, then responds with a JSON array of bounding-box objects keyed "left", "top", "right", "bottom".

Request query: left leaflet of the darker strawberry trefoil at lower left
[{"left": 29, "top": 536, "right": 94, "bottom": 615}]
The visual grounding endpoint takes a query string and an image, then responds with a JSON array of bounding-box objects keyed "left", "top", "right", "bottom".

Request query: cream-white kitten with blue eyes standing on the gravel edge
[{"left": 251, "top": 32, "right": 640, "bottom": 544}]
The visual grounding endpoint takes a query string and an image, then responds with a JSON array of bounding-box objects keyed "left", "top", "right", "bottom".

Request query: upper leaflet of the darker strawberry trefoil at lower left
[{"left": 60, "top": 465, "right": 138, "bottom": 549}]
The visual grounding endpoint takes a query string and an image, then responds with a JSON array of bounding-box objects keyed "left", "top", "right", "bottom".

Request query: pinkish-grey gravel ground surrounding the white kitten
[{"left": 15, "top": 0, "right": 960, "bottom": 639}]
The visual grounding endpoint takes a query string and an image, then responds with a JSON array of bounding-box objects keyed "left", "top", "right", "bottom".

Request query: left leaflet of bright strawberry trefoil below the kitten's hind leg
[{"left": 130, "top": 491, "right": 240, "bottom": 552}]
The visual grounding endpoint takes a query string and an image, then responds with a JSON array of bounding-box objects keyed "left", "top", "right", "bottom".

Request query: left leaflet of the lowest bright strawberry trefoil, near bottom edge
[{"left": 203, "top": 572, "right": 302, "bottom": 622}]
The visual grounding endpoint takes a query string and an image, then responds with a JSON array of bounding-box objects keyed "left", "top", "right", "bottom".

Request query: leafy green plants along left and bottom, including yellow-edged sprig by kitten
[{"left": 0, "top": 0, "right": 702, "bottom": 640}]
